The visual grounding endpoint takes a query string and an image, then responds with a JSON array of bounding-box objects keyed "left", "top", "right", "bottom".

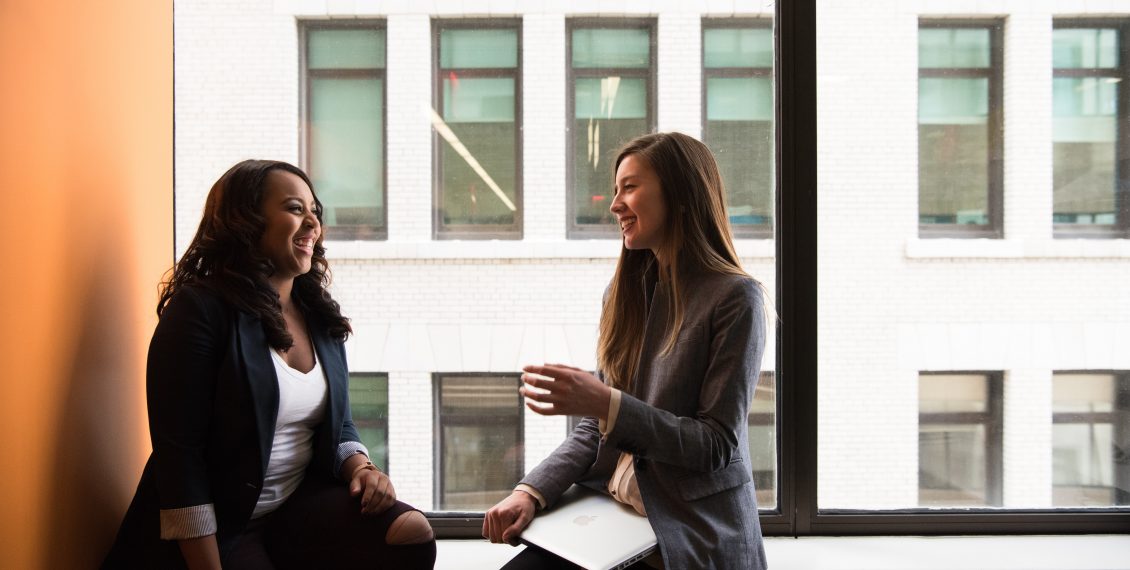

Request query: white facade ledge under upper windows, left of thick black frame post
[{"left": 325, "top": 240, "right": 775, "bottom": 260}]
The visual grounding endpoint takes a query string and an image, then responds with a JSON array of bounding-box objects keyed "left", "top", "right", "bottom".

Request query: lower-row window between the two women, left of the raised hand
[{"left": 435, "top": 374, "right": 525, "bottom": 511}]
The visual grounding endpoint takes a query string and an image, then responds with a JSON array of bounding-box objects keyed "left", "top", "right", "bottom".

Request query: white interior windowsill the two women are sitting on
[{"left": 435, "top": 535, "right": 1130, "bottom": 570}]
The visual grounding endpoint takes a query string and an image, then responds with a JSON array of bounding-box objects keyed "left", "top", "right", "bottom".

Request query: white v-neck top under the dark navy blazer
[{"left": 251, "top": 348, "right": 327, "bottom": 518}]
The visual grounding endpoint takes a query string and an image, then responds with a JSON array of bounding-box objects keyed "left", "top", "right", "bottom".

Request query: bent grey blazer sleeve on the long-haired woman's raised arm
[{"left": 606, "top": 279, "right": 765, "bottom": 472}]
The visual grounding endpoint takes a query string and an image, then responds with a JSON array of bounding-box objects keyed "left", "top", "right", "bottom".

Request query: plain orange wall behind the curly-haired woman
[{"left": 0, "top": 0, "right": 173, "bottom": 569}]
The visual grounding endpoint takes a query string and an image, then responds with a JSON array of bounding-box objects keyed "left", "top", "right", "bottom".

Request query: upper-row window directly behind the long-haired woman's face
[{"left": 566, "top": 19, "right": 655, "bottom": 238}]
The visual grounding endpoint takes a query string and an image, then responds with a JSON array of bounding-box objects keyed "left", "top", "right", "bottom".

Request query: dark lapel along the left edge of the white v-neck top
[{"left": 238, "top": 311, "right": 279, "bottom": 475}]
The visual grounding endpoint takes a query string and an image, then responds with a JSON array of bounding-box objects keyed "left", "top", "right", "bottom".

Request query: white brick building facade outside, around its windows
[{"left": 175, "top": 0, "right": 1130, "bottom": 509}]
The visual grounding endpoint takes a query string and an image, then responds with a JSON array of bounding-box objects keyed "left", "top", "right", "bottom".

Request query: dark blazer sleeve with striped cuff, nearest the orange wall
[{"left": 146, "top": 288, "right": 225, "bottom": 539}]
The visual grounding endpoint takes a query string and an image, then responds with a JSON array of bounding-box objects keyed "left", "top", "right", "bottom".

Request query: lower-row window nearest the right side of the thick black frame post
[{"left": 919, "top": 373, "right": 1002, "bottom": 507}]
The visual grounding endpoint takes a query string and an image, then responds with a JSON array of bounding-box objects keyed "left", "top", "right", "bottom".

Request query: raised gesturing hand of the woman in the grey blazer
[{"left": 519, "top": 364, "right": 612, "bottom": 420}]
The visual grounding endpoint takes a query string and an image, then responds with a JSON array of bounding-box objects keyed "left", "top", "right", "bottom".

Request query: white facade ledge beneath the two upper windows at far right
[{"left": 906, "top": 239, "right": 1130, "bottom": 259}]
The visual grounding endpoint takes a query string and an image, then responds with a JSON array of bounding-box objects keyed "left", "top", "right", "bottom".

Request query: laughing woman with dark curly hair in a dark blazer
[{"left": 103, "top": 161, "right": 435, "bottom": 569}]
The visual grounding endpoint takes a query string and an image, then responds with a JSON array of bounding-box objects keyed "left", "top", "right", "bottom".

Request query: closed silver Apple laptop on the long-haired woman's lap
[{"left": 522, "top": 485, "right": 655, "bottom": 570}]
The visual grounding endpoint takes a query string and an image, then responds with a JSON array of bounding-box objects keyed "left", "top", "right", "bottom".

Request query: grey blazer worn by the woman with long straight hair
[{"left": 522, "top": 266, "right": 766, "bottom": 570}]
